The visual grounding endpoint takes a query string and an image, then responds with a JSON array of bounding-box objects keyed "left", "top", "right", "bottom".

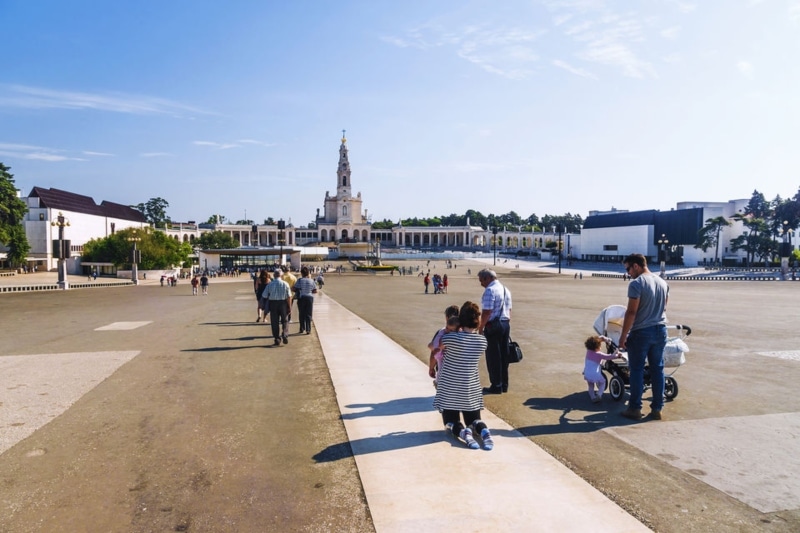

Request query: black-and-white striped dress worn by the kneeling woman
[{"left": 433, "top": 331, "right": 486, "bottom": 411}]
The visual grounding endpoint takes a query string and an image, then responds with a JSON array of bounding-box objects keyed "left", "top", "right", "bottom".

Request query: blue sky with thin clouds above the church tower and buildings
[{"left": 0, "top": 0, "right": 800, "bottom": 226}]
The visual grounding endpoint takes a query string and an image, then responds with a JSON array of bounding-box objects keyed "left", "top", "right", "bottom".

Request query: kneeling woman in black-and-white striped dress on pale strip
[{"left": 433, "top": 302, "right": 494, "bottom": 450}]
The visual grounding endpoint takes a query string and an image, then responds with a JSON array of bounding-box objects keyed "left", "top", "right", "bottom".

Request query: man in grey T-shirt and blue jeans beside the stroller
[{"left": 619, "top": 254, "right": 669, "bottom": 420}]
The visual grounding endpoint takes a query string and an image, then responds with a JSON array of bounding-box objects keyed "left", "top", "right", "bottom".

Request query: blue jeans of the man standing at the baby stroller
[{"left": 625, "top": 325, "right": 667, "bottom": 411}]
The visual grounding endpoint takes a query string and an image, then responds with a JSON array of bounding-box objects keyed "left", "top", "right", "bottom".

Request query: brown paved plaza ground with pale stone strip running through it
[{"left": 0, "top": 260, "right": 800, "bottom": 531}]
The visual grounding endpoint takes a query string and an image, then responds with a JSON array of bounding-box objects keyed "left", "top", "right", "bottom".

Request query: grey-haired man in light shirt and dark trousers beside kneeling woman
[{"left": 478, "top": 268, "right": 511, "bottom": 394}]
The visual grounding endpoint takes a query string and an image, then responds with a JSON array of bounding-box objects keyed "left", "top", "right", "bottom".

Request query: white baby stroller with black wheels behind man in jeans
[{"left": 594, "top": 305, "right": 692, "bottom": 401}]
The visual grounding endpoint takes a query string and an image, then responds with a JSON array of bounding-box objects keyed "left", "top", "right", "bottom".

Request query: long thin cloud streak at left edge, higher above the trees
[{"left": 0, "top": 84, "right": 213, "bottom": 117}]
